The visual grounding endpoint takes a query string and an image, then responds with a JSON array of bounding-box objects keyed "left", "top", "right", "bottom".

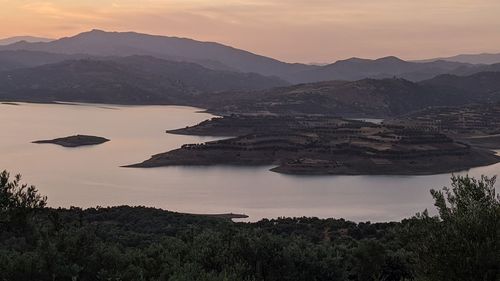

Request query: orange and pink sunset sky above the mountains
[{"left": 0, "top": 0, "right": 500, "bottom": 62}]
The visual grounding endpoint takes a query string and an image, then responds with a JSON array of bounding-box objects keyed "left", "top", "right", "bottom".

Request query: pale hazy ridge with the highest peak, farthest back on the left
[{"left": 0, "top": 30, "right": 313, "bottom": 79}]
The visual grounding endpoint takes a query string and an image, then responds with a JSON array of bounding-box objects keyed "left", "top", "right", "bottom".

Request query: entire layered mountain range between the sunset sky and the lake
[{"left": 0, "top": 30, "right": 500, "bottom": 117}]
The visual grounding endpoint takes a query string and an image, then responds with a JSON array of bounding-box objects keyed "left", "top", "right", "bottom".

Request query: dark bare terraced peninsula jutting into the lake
[{"left": 130, "top": 115, "right": 500, "bottom": 175}]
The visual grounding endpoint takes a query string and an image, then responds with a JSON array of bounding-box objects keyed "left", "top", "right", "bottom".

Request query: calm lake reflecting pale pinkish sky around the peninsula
[{"left": 0, "top": 100, "right": 500, "bottom": 221}]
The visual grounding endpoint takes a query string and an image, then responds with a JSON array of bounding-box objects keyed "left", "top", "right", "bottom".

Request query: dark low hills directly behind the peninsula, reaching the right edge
[{"left": 201, "top": 72, "right": 500, "bottom": 117}]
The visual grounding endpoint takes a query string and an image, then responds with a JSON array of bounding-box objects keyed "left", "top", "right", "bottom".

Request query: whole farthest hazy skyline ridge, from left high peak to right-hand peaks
[{"left": 0, "top": 30, "right": 494, "bottom": 84}]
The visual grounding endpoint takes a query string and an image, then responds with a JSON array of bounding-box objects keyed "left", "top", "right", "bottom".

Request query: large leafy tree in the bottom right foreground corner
[{"left": 411, "top": 176, "right": 500, "bottom": 281}]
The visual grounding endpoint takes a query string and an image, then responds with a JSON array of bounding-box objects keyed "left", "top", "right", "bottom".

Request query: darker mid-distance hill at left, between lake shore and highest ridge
[{"left": 0, "top": 56, "right": 286, "bottom": 104}]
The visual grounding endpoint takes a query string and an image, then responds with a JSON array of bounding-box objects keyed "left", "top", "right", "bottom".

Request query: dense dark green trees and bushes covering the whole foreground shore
[{"left": 0, "top": 172, "right": 500, "bottom": 281}]
